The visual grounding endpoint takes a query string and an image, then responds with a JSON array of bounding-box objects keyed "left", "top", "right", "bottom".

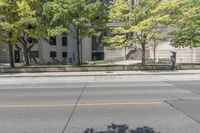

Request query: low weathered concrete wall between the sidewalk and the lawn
[{"left": 0, "top": 65, "right": 171, "bottom": 73}]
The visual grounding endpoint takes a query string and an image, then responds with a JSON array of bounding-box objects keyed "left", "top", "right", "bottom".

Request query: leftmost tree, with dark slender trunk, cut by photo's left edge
[{"left": 0, "top": 0, "right": 18, "bottom": 67}]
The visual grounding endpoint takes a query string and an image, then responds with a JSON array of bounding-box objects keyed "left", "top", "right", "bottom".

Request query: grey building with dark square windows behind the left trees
[{"left": 0, "top": 35, "right": 104, "bottom": 64}]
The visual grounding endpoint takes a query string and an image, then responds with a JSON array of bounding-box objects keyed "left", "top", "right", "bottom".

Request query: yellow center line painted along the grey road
[{"left": 0, "top": 102, "right": 162, "bottom": 108}]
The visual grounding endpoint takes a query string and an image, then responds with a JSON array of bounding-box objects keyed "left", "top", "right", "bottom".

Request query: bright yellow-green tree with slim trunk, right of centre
[{"left": 105, "top": 0, "right": 168, "bottom": 65}]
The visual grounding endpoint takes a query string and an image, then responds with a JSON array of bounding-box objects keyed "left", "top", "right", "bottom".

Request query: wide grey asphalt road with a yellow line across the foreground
[{"left": 0, "top": 75, "right": 200, "bottom": 133}]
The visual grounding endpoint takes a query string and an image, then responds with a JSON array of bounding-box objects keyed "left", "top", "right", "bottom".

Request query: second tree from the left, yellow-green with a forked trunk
[{"left": 16, "top": 0, "right": 47, "bottom": 65}]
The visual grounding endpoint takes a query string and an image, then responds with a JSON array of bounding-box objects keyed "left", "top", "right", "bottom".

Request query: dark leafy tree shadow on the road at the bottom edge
[{"left": 84, "top": 124, "right": 160, "bottom": 133}]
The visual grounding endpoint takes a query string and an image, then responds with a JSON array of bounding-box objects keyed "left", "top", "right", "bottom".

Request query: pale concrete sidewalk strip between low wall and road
[{"left": 0, "top": 70, "right": 200, "bottom": 78}]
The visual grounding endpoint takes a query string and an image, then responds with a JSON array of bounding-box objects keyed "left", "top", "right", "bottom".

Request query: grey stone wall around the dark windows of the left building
[{"left": 0, "top": 35, "right": 92, "bottom": 64}]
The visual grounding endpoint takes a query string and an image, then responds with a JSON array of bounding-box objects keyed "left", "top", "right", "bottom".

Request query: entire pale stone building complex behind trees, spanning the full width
[{"left": 0, "top": 0, "right": 200, "bottom": 64}]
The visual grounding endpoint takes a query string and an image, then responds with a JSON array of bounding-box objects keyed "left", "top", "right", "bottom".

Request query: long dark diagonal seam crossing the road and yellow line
[{"left": 62, "top": 82, "right": 87, "bottom": 133}]
